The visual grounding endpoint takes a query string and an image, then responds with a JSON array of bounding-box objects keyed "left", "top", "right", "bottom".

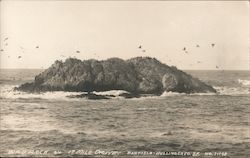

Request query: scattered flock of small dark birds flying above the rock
[{"left": 0, "top": 37, "right": 219, "bottom": 69}]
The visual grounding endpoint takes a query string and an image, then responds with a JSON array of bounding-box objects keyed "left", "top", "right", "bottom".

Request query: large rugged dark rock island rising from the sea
[{"left": 16, "top": 57, "right": 216, "bottom": 94}]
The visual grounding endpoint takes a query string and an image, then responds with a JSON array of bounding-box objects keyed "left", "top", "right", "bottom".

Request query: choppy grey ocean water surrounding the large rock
[{"left": 0, "top": 69, "right": 250, "bottom": 158}]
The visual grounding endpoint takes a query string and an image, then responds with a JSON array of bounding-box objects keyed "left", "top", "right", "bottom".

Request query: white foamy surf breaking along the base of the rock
[{"left": 0, "top": 85, "right": 250, "bottom": 100}]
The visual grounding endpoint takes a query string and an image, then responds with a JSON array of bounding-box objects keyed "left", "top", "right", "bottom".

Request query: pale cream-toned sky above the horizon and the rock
[{"left": 0, "top": 0, "right": 250, "bottom": 70}]
